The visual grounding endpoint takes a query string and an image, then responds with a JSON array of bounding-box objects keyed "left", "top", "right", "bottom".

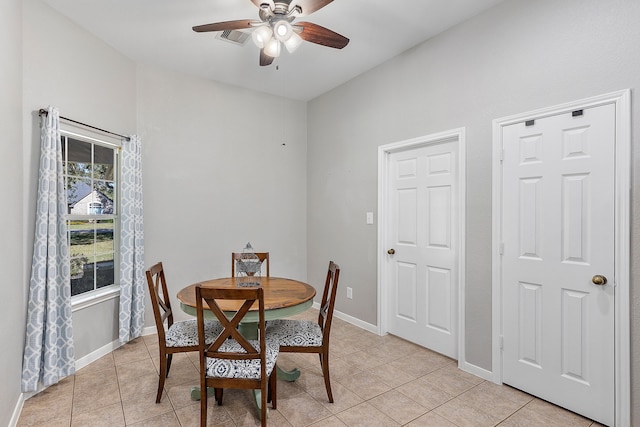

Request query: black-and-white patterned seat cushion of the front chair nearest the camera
[{"left": 206, "top": 339, "right": 280, "bottom": 380}]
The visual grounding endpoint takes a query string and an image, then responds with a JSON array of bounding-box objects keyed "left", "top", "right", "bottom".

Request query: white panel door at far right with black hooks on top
[{"left": 502, "top": 104, "right": 615, "bottom": 425}]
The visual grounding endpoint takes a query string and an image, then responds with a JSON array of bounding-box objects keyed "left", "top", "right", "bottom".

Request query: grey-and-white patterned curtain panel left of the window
[{"left": 22, "top": 107, "right": 75, "bottom": 392}]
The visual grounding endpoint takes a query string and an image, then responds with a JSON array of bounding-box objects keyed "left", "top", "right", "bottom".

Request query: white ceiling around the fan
[{"left": 43, "top": 0, "right": 502, "bottom": 100}]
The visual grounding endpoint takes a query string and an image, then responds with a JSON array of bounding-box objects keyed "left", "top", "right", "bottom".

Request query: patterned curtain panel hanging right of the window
[{"left": 119, "top": 135, "right": 146, "bottom": 343}]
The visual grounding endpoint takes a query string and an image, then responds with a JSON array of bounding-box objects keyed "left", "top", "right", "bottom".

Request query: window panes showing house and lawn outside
[{"left": 62, "top": 135, "right": 119, "bottom": 296}]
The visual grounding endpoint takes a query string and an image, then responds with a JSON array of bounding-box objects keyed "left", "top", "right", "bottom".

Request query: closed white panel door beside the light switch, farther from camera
[{"left": 387, "top": 142, "right": 458, "bottom": 358}]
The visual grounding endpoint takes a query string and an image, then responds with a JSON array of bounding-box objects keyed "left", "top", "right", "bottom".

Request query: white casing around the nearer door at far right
[{"left": 492, "top": 90, "right": 631, "bottom": 426}]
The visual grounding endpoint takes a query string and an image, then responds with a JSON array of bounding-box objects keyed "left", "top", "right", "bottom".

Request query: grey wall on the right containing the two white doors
[{"left": 308, "top": 0, "right": 640, "bottom": 422}]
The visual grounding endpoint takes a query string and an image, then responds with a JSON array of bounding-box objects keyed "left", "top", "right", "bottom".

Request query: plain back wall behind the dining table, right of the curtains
[{"left": 138, "top": 65, "right": 308, "bottom": 324}]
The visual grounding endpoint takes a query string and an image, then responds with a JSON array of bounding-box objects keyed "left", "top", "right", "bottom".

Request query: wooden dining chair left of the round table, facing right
[{"left": 146, "top": 262, "right": 222, "bottom": 403}]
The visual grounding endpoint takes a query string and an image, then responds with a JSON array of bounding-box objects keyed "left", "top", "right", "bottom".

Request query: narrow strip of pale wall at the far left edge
[{"left": 0, "top": 0, "right": 26, "bottom": 425}]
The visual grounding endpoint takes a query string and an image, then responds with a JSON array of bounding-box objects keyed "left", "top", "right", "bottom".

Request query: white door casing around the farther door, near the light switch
[{"left": 377, "top": 128, "right": 465, "bottom": 359}]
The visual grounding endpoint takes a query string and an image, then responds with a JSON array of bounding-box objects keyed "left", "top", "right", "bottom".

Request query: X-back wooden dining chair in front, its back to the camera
[{"left": 196, "top": 285, "right": 279, "bottom": 427}]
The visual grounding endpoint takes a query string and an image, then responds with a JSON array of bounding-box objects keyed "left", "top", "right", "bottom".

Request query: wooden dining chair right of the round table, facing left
[{"left": 267, "top": 261, "right": 340, "bottom": 403}]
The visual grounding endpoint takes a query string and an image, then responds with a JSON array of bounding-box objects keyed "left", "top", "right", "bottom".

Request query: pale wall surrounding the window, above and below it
[{"left": 21, "top": 0, "right": 136, "bottom": 359}]
